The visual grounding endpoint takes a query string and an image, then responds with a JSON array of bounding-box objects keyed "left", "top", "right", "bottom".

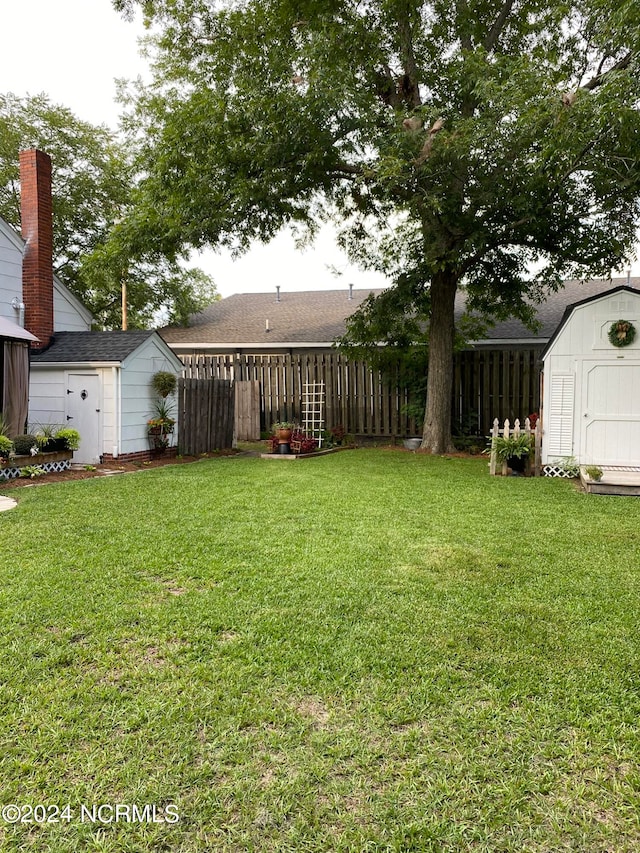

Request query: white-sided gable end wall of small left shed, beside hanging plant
[{"left": 120, "top": 338, "right": 180, "bottom": 453}]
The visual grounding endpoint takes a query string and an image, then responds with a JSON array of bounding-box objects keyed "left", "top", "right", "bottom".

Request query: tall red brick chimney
[{"left": 20, "top": 148, "right": 53, "bottom": 349}]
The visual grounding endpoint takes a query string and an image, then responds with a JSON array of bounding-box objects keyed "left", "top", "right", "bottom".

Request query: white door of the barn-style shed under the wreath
[{"left": 579, "top": 360, "right": 640, "bottom": 465}]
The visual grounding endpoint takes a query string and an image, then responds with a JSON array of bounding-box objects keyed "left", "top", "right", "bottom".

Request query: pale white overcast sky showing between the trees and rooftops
[{"left": 0, "top": 0, "right": 640, "bottom": 296}]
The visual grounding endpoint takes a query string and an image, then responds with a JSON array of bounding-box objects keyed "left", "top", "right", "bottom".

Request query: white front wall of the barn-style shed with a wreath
[{"left": 542, "top": 291, "right": 640, "bottom": 464}]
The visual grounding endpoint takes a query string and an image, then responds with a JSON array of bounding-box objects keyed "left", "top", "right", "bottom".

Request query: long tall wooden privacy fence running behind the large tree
[{"left": 182, "top": 348, "right": 541, "bottom": 438}]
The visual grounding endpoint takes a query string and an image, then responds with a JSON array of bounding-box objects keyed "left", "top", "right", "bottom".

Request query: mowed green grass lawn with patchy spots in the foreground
[{"left": 0, "top": 450, "right": 640, "bottom": 853}]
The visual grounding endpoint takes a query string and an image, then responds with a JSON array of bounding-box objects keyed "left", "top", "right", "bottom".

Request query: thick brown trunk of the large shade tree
[{"left": 421, "top": 268, "right": 458, "bottom": 453}]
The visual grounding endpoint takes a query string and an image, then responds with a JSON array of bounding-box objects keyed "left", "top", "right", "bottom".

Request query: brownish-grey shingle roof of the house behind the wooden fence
[{"left": 160, "top": 278, "right": 640, "bottom": 349}]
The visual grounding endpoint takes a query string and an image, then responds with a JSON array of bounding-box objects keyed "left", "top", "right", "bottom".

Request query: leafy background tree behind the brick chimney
[{"left": 0, "top": 93, "right": 216, "bottom": 328}]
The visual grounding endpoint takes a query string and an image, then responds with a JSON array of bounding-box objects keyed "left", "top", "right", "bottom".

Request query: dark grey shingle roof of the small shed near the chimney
[{"left": 31, "top": 329, "right": 155, "bottom": 364}]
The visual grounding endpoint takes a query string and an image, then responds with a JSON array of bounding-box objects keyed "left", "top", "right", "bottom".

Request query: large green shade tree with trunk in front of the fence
[{"left": 114, "top": 0, "right": 640, "bottom": 452}]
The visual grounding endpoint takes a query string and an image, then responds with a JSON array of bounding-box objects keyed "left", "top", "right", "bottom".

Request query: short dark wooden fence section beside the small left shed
[{"left": 178, "top": 379, "right": 235, "bottom": 456}]
